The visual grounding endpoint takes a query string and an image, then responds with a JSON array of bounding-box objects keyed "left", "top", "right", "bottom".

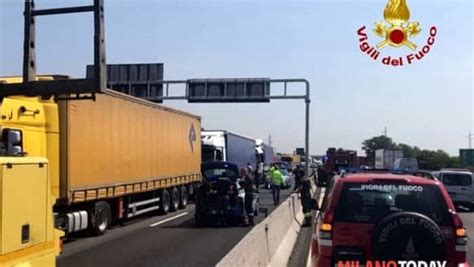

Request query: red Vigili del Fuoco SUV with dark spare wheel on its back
[{"left": 311, "top": 172, "right": 469, "bottom": 267}]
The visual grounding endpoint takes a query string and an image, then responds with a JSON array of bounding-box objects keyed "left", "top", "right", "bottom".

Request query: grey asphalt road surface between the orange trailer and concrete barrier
[{"left": 57, "top": 186, "right": 290, "bottom": 267}]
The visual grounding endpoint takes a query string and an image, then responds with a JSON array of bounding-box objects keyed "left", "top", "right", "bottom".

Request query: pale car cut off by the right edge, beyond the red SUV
[{"left": 432, "top": 169, "right": 474, "bottom": 210}]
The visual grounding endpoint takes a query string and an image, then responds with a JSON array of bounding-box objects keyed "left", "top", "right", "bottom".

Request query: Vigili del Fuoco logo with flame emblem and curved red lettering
[{"left": 357, "top": 0, "right": 437, "bottom": 66}]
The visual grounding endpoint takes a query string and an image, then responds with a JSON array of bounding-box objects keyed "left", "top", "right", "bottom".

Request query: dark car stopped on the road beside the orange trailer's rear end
[{"left": 195, "top": 162, "right": 258, "bottom": 226}]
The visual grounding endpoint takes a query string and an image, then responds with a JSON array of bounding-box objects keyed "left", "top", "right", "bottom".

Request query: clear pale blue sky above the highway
[{"left": 0, "top": 0, "right": 474, "bottom": 155}]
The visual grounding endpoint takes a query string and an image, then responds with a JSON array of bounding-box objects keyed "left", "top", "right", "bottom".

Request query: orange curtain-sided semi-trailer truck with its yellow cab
[{"left": 0, "top": 77, "right": 201, "bottom": 237}]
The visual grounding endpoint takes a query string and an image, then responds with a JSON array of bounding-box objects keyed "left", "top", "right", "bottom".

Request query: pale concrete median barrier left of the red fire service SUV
[{"left": 216, "top": 181, "right": 317, "bottom": 267}]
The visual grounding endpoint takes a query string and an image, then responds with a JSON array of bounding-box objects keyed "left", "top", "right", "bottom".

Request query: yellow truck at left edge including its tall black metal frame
[{"left": 0, "top": 0, "right": 106, "bottom": 267}]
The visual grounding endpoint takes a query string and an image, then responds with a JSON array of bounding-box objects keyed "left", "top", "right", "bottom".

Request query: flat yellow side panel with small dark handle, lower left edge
[{"left": 0, "top": 158, "right": 51, "bottom": 255}]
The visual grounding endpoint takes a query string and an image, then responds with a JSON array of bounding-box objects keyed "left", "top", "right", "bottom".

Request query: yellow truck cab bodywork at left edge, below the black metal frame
[{"left": 0, "top": 77, "right": 62, "bottom": 266}]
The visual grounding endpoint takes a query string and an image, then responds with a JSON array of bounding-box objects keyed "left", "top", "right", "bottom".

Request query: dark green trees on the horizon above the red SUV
[{"left": 362, "top": 135, "right": 460, "bottom": 170}]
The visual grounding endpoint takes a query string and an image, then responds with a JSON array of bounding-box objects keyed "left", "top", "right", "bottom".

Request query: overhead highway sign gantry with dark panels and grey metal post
[{"left": 87, "top": 64, "right": 311, "bottom": 178}]
